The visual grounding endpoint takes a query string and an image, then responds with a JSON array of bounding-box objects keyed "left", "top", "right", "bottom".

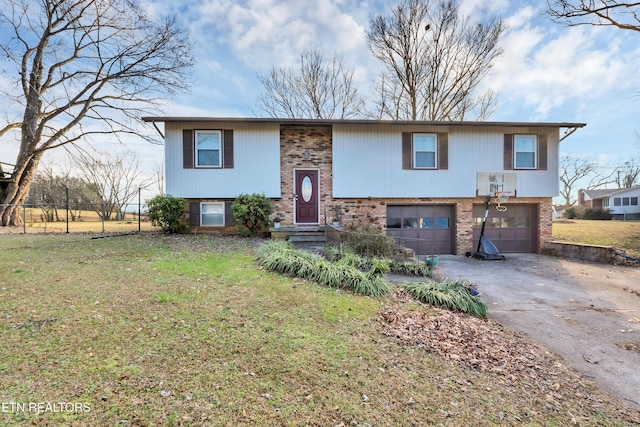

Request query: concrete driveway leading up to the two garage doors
[{"left": 436, "top": 254, "right": 640, "bottom": 409}]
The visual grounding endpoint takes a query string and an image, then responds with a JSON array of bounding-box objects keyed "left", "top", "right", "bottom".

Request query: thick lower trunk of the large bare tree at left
[{"left": 0, "top": 153, "right": 42, "bottom": 226}]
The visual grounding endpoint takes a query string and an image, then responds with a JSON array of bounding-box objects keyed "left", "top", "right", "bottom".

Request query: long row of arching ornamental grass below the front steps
[{"left": 258, "top": 242, "right": 392, "bottom": 296}]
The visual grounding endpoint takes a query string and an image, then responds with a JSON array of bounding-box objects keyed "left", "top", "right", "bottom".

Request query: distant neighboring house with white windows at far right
[{"left": 578, "top": 185, "right": 640, "bottom": 219}]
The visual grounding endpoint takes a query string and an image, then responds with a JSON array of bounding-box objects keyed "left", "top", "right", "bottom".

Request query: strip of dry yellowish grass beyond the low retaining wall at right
[{"left": 553, "top": 219, "right": 640, "bottom": 257}]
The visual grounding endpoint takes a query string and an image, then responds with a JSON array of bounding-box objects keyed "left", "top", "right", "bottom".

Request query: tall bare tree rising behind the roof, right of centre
[{"left": 367, "top": 0, "right": 505, "bottom": 121}]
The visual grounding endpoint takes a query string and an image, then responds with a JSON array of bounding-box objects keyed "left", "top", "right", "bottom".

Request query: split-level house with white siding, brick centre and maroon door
[{"left": 144, "top": 117, "right": 585, "bottom": 254}]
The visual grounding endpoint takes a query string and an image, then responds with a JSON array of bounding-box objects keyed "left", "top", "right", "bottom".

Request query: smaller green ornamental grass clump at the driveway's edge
[{"left": 402, "top": 280, "right": 487, "bottom": 319}]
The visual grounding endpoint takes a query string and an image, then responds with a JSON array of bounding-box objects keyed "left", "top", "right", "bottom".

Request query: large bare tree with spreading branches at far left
[{"left": 0, "top": 0, "right": 193, "bottom": 225}]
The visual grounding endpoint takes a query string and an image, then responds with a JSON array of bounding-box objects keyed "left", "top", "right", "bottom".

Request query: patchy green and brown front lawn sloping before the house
[{"left": 0, "top": 235, "right": 640, "bottom": 426}]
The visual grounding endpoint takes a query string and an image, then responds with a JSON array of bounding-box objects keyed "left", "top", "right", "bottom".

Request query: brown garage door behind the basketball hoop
[{"left": 473, "top": 203, "right": 538, "bottom": 253}]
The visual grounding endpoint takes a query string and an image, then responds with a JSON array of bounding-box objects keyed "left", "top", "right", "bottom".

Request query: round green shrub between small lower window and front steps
[{"left": 231, "top": 194, "right": 273, "bottom": 236}]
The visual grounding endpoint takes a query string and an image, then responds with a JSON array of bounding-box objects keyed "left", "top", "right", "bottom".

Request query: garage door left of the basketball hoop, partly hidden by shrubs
[{"left": 387, "top": 205, "right": 455, "bottom": 255}]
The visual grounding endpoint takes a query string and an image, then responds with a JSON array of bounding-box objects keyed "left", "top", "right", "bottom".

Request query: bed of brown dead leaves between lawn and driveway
[{"left": 378, "top": 291, "right": 640, "bottom": 424}]
